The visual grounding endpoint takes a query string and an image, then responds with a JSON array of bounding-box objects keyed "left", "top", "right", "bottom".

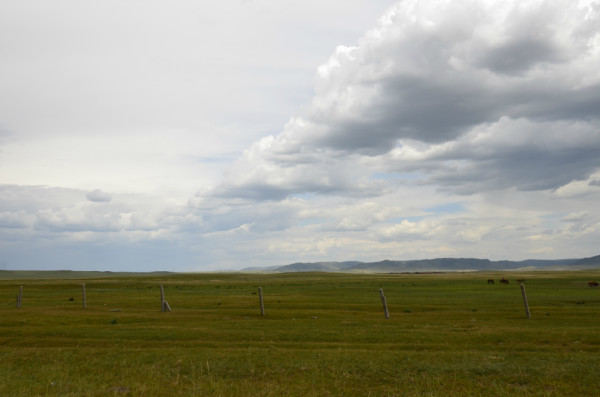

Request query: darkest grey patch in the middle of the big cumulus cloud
[{"left": 318, "top": 76, "right": 492, "bottom": 148}]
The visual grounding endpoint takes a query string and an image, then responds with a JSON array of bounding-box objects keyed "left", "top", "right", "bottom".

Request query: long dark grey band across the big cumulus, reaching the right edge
[{"left": 314, "top": 67, "right": 600, "bottom": 155}]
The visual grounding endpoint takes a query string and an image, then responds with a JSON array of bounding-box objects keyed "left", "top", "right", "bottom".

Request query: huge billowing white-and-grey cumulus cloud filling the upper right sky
[{"left": 206, "top": 0, "right": 600, "bottom": 200}]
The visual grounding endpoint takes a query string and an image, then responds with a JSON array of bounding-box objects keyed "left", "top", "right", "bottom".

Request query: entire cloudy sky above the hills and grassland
[{"left": 0, "top": 0, "right": 600, "bottom": 272}]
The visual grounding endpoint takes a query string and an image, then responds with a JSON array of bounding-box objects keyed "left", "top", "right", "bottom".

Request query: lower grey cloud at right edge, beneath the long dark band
[{"left": 390, "top": 119, "right": 600, "bottom": 194}]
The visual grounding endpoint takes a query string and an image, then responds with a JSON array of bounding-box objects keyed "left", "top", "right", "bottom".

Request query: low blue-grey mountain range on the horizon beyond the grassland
[{"left": 242, "top": 255, "right": 600, "bottom": 273}]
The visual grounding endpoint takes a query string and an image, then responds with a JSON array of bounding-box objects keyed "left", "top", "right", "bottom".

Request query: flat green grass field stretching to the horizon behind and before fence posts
[{"left": 0, "top": 271, "right": 600, "bottom": 396}]
